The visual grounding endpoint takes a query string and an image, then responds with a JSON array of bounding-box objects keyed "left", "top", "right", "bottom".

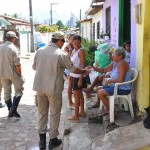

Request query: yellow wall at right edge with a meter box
[{"left": 135, "top": 0, "right": 150, "bottom": 112}]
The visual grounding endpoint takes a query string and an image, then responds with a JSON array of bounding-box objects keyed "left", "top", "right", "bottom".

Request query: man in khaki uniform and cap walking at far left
[{"left": 0, "top": 31, "right": 24, "bottom": 118}]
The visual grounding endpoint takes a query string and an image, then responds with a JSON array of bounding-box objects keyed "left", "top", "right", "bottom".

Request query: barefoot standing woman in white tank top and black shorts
[{"left": 68, "top": 35, "right": 87, "bottom": 120}]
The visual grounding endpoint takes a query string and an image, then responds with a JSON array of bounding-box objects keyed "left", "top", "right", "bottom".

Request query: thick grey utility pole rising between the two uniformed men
[{"left": 29, "top": 0, "right": 34, "bottom": 52}]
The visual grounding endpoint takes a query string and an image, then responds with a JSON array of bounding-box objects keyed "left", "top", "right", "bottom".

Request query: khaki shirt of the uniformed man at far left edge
[{"left": 0, "top": 41, "right": 20, "bottom": 78}]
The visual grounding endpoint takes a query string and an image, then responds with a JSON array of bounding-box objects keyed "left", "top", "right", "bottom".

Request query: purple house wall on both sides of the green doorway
[{"left": 103, "top": 0, "right": 137, "bottom": 67}]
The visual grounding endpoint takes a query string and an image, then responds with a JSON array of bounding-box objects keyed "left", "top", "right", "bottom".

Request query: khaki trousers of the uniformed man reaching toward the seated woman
[{"left": 37, "top": 92, "right": 62, "bottom": 139}]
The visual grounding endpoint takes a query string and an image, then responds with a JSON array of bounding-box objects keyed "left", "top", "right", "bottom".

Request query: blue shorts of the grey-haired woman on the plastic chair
[{"left": 103, "top": 85, "right": 131, "bottom": 96}]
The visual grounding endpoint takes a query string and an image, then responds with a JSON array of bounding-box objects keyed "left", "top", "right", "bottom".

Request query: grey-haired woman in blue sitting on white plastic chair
[{"left": 90, "top": 47, "right": 132, "bottom": 116}]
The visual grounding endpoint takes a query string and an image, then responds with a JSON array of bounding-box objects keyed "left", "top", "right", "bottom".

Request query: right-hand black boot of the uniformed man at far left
[{"left": 9, "top": 96, "right": 22, "bottom": 118}]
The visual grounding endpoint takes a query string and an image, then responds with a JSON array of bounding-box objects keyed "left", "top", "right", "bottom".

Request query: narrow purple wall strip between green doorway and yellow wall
[{"left": 131, "top": 0, "right": 137, "bottom": 67}]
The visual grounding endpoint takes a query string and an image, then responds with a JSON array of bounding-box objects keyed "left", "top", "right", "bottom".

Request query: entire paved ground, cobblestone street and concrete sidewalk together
[{"left": 0, "top": 54, "right": 150, "bottom": 150}]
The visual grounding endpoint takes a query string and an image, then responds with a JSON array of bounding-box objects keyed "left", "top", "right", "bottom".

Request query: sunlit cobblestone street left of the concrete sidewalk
[{"left": 0, "top": 54, "right": 64, "bottom": 150}]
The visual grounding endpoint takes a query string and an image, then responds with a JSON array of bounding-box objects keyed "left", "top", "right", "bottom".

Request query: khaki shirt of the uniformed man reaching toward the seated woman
[{"left": 33, "top": 43, "right": 76, "bottom": 94}]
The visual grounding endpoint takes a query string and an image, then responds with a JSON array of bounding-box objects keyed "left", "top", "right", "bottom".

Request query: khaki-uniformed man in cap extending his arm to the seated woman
[{"left": 33, "top": 32, "right": 88, "bottom": 149}]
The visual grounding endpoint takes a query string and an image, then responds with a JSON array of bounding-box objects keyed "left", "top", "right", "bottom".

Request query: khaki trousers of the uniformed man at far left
[{"left": 1, "top": 77, "right": 24, "bottom": 101}]
